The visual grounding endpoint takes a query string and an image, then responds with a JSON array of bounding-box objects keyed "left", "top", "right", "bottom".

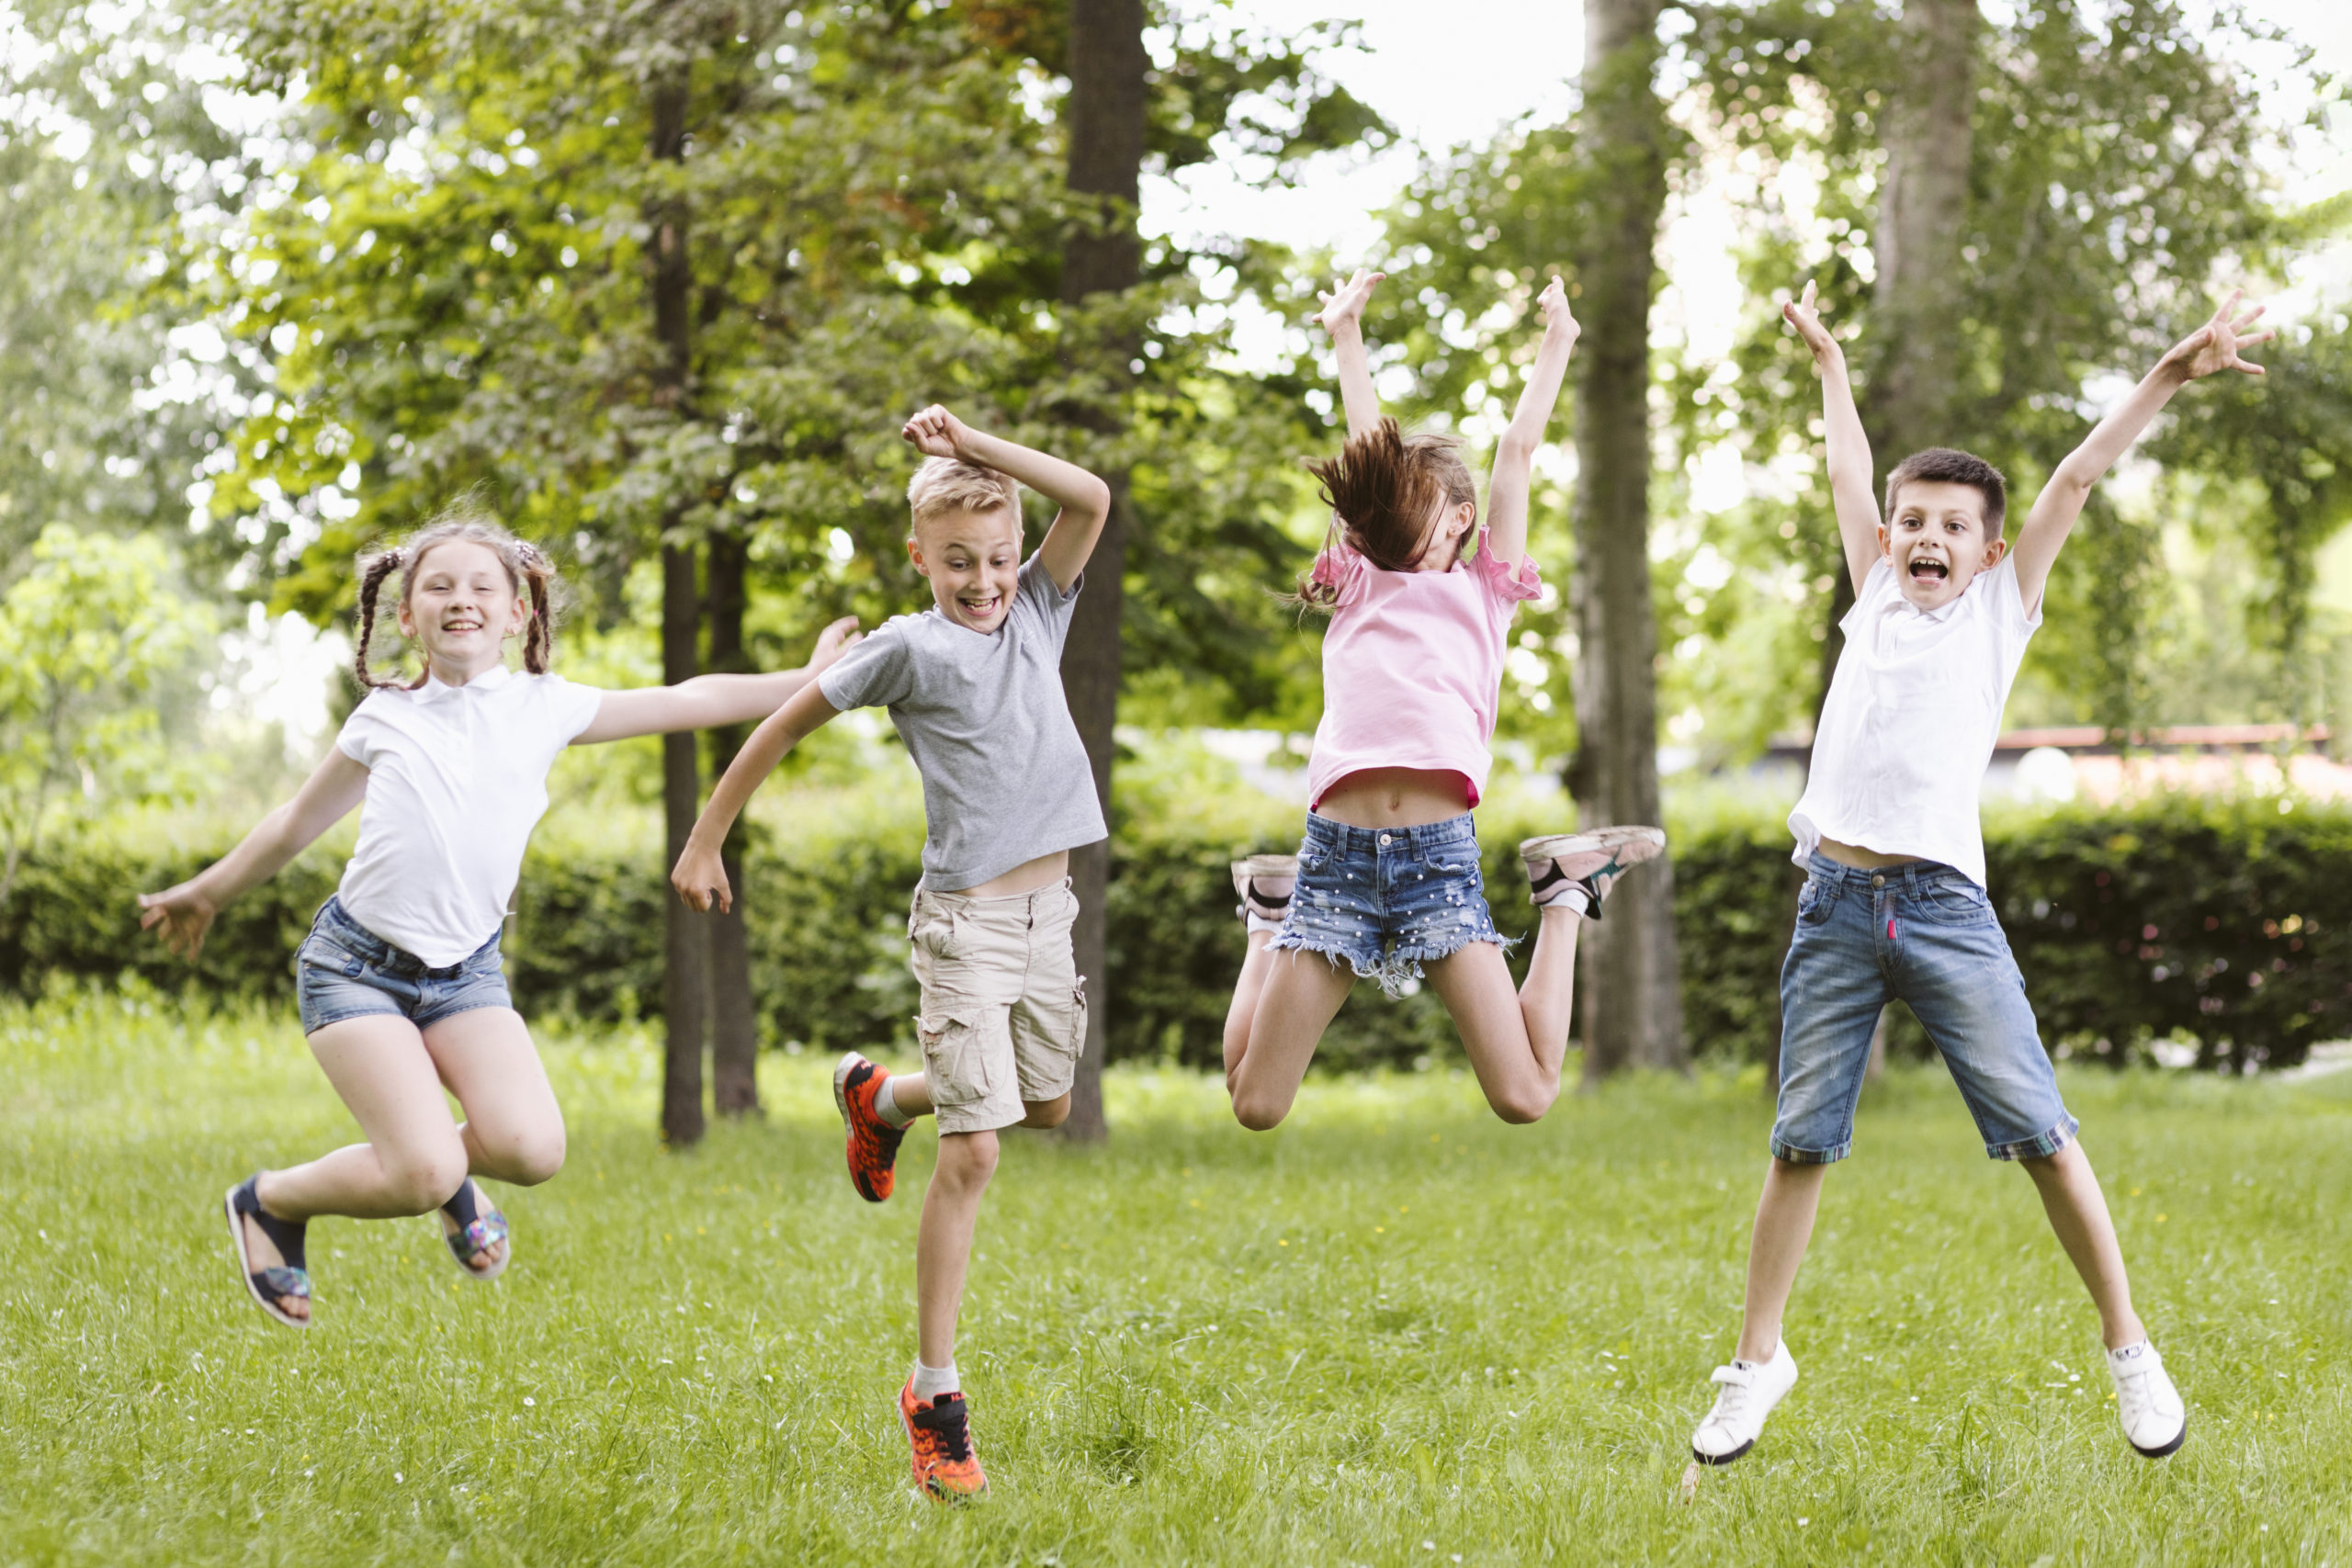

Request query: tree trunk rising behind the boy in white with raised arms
[{"left": 1814, "top": 0, "right": 1983, "bottom": 728}]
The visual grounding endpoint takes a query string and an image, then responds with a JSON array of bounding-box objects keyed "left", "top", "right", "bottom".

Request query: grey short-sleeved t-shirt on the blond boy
[{"left": 816, "top": 555, "right": 1110, "bottom": 894}]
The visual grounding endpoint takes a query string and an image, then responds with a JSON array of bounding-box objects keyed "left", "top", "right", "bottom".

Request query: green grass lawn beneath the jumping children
[{"left": 0, "top": 995, "right": 2352, "bottom": 1568}]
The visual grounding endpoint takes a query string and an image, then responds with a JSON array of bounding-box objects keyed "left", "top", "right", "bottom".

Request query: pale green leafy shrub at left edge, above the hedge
[{"left": 0, "top": 522, "right": 217, "bottom": 903}]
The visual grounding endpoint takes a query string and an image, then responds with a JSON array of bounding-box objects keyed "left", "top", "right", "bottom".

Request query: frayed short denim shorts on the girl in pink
[{"left": 1272, "top": 811, "right": 1510, "bottom": 997}]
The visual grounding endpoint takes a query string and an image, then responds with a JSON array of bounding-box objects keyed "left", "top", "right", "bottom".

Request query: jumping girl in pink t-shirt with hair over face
[{"left": 1226, "top": 273, "right": 1665, "bottom": 1128}]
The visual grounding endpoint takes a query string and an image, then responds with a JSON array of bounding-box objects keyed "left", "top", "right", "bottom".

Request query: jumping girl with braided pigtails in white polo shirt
[{"left": 139, "top": 508, "right": 856, "bottom": 1328}]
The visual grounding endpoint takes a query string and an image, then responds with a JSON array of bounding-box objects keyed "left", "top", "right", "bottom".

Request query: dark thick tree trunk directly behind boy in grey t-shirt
[{"left": 1061, "top": 0, "right": 1150, "bottom": 1143}]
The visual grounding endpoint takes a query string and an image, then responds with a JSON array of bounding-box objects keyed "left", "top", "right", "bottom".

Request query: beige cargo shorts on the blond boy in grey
[{"left": 906, "top": 877, "right": 1087, "bottom": 1134}]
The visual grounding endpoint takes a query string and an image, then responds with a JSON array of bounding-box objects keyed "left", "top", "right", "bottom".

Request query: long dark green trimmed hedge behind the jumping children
[{"left": 14, "top": 797, "right": 2352, "bottom": 1069}]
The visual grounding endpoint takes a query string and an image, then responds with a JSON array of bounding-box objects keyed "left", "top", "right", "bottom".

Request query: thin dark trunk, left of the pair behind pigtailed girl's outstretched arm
[{"left": 647, "top": 77, "right": 710, "bottom": 1149}]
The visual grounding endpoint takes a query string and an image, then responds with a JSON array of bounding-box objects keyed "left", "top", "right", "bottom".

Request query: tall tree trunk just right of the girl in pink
[{"left": 1571, "top": 0, "right": 1687, "bottom": 1079}]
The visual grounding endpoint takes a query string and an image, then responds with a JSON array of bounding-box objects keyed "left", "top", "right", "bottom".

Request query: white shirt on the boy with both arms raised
[{"left": 1788, "top": 555, "right": 2041, "bottom": 886}]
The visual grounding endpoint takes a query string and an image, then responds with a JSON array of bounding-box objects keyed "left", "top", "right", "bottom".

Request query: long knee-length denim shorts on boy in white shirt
[{"left": 1771, "top": 853, "right": 2082, "bottom": 1164}]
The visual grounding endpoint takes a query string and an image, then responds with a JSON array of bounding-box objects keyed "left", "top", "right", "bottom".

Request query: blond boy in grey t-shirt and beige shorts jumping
[{"left": 671, "top": 407, "right": 1110, "bottom": 1500}]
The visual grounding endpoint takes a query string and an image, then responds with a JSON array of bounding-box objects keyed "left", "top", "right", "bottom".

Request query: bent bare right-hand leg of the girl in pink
[{"left": 1428, "top": 909, "right": 1583, "bottom": 1122}]
